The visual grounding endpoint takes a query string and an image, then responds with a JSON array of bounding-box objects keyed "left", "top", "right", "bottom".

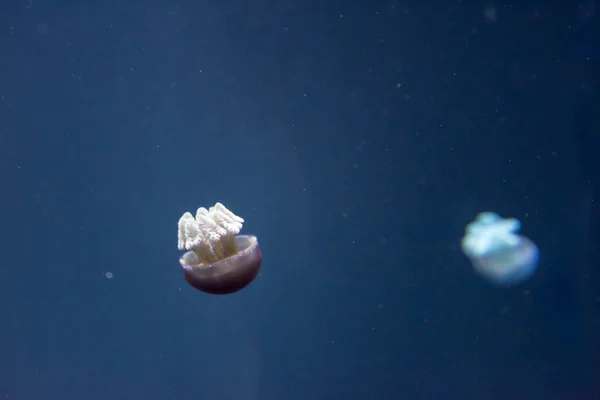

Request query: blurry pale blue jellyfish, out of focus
[{"left": 461, "top": 211, "right": 539, "bottom": 286}]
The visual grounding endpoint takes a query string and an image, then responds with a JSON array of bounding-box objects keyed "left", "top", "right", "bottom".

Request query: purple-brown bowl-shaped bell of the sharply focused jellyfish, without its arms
[{"left": 179, "top": 235, "right": 262, "bottom": 294}]
